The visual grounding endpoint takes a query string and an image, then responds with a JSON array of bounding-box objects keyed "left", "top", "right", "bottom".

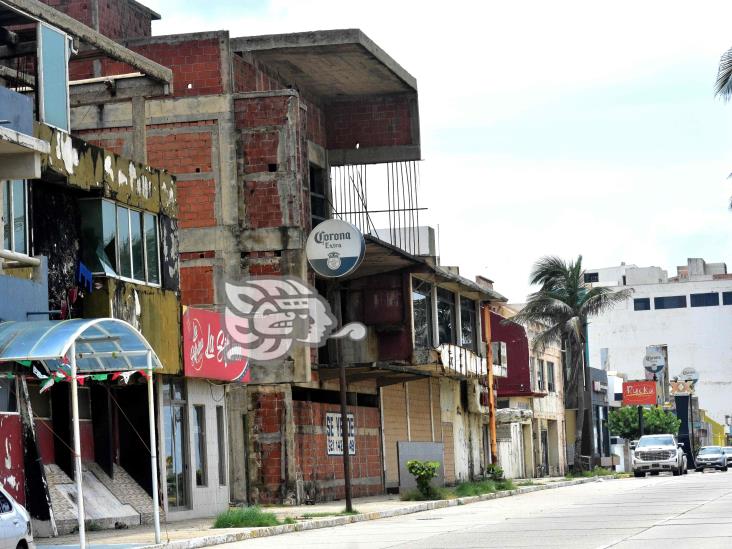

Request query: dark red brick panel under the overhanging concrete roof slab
[{"left": 325, "top": 95, "right": 414, "bottom": 149}]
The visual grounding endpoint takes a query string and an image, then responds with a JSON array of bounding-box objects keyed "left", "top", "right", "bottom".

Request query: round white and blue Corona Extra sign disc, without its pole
[{"left": 305, "top": 219, "right": 366, "bottom": 278}]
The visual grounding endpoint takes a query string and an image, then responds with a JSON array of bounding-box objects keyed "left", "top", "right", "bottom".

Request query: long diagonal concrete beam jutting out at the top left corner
[{"left": 0, "top": 0, "right": 173, "bottom": 84}]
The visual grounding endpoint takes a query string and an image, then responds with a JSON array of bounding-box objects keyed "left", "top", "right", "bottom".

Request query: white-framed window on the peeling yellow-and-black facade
[{"left": 80, "top": 199, "right": 160, "bottom": 284}]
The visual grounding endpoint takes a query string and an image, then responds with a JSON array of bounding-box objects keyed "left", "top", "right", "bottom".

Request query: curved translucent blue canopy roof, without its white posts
[{"left": 0, "top": 318, "right": 162, "bottom": 373}]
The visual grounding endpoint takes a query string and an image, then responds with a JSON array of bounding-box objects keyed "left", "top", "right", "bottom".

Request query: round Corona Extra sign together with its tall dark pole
[{"left": 305, "top": 219, "right": 366, "bottom": 513}]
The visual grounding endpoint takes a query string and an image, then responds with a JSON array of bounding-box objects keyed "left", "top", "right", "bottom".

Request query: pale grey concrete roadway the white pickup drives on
[{"left": 220, "top": 472, "right": 732, "bottom": 549}]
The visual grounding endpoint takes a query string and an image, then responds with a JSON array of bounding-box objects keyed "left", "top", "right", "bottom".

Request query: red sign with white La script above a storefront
[{"left": 183, "top": 307, "right": 250, "bottom": 383}]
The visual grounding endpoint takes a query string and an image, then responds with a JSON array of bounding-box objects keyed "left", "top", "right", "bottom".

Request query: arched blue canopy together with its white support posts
[{"left": 0, "top": 318, "right": 162, "bottom": 549}]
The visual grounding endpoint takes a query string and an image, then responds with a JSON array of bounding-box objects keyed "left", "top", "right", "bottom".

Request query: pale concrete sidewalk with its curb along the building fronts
[{"left": 36, "top": 477, "right": 598, "bottom": 549}]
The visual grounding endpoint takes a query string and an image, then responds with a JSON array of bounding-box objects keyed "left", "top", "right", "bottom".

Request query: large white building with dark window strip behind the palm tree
[{"left": 584, "top": 258, "right": 732, "bottom": 422}]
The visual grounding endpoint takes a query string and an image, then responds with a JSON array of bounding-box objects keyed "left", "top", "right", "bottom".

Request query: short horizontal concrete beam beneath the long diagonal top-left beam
[{"left": 69, "top": 73, "right": 170, "bottom": 107}]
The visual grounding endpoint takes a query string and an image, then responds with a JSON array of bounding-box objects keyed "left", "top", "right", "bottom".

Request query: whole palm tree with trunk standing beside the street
[{"left": 511, "top": 255, "right": 632, "bottom": 469}]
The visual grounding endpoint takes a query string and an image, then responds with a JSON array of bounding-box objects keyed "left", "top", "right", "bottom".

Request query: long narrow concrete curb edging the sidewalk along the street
[{"left": 137, "top": 477, "right": 610, "bottom": 549}]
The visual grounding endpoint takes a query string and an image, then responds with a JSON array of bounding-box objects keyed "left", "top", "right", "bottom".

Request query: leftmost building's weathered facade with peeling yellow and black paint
[{"left": 0, "top": 1, "right": 189, "bottom": 536}]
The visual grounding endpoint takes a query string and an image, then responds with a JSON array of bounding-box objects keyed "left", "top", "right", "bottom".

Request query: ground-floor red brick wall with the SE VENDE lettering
[{"left": 293, "top": 401, "right": 384, "bottom": 501}]
